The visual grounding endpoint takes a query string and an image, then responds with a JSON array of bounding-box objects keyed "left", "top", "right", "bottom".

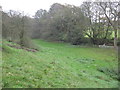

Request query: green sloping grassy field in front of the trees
[{"left": 2, "top": 40, "right": 118, "bottom": 88}]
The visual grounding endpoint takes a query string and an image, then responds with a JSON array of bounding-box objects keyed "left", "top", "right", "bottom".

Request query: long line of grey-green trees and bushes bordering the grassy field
[{"left": 2, "top": 2, "right": 120, "bottom": 47}]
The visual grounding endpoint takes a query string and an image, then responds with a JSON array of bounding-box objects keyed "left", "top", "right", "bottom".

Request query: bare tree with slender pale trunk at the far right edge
[{"left": 98, "top": 2, "right": 120, "bottom": 48}]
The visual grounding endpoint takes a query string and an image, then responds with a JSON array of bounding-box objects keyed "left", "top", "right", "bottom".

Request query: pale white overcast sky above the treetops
[{"left": 0, "top": 0, "right": 84, "bottom": 16}]
